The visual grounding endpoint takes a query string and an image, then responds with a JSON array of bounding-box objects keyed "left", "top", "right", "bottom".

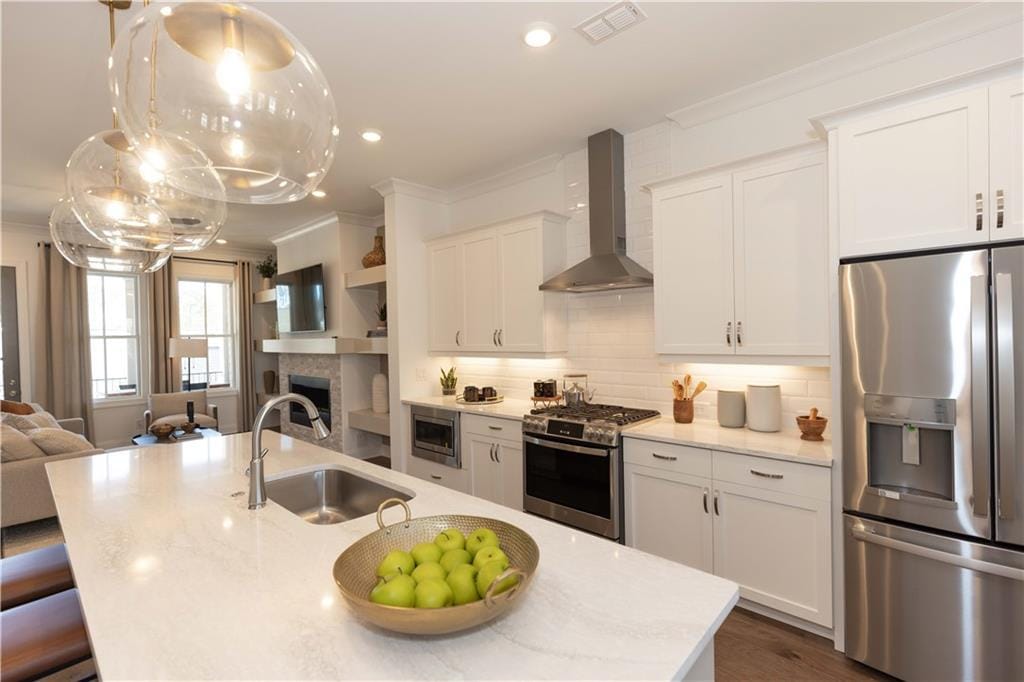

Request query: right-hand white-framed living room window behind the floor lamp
[{"left": 177, "top": 273, "right": 237, "bottom": 389}]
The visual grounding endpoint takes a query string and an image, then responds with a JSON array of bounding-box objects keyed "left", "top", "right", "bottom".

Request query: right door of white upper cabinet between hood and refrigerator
[{"left": 732, "top": 152, "right": 828, "bottom": 355}]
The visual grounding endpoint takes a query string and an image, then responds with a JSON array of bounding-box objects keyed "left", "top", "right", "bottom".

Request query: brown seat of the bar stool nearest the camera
[{"left": 0, "top": 589, "right": 92, "bottom": 682}]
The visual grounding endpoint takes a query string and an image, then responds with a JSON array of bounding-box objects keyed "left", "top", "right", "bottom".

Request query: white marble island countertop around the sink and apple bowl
[{"left": 46, "top": 432, "right": 738, "bottom": 680}]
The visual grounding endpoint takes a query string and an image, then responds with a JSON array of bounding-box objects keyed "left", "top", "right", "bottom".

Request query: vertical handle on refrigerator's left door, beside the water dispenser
[{"left": 971, "top": 274, "right": 989, "bottom": 517}]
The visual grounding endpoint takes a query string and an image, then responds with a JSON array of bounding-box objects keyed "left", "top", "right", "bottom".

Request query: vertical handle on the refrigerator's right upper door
[{"left": 995, "top": 272, "right": 1017, "bottom": 519}]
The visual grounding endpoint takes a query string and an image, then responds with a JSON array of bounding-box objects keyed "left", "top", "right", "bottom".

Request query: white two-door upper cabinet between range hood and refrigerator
[{"left": 651, "top": 151, "right": 828, "bottom": 357}]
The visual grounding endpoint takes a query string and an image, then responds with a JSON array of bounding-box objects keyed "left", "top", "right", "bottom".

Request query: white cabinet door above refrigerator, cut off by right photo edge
[{"left": 986, "top": 79, "right": 1024, "bottom": 240}]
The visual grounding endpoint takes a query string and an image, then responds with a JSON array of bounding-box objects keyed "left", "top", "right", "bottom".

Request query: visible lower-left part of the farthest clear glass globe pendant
[{"left": 50, "top": 197, "right": 171, "bottom": 272}]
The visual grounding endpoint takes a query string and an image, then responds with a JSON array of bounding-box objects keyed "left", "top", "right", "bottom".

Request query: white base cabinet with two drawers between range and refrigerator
[{"left": 625, "top": 438, "right": 833, "bottom": 628}]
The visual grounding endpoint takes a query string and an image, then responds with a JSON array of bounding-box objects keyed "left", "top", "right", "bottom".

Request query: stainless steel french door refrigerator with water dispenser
[{"left": 840, "top": 246, "right": 1024, "bottom": 680}]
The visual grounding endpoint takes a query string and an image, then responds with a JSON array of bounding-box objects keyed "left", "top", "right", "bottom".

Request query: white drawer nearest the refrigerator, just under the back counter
[{"left": 714, "top": 451, "right": 831, "bottom": 500}]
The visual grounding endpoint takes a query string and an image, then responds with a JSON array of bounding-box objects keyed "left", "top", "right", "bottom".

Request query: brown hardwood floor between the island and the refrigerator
[{"left": 715, "top": 608, "right": 893, "bottom": 682}]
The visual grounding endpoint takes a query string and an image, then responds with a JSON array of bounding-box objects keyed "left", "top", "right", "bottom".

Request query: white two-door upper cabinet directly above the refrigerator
[{"left": 829, "top": 73, "right": 1024, "bottom": 257}]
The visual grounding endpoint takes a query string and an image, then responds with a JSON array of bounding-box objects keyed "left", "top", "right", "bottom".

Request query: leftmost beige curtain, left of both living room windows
[{"left": 33, "top": 244, "right": 94, "bottom": 439}]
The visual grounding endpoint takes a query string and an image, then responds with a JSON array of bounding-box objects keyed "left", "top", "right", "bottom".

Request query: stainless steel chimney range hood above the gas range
[{"left": 541, "top": 128, "right": 654, "bottom": 294}]
